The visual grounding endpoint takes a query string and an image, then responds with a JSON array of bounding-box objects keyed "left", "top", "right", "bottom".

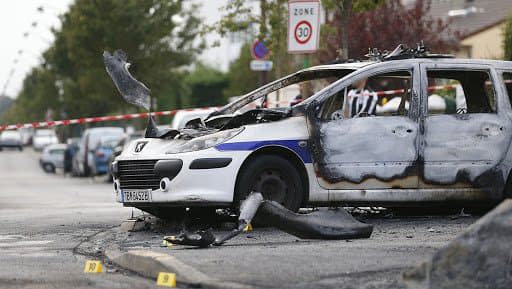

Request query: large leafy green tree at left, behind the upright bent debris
[{"left": 4, "top": 0, "right": 203, "bottom": 121}]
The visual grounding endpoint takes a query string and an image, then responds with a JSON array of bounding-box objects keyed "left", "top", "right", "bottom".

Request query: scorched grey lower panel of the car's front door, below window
[{"left": 319, "top": 117, "right": 418, "bottom": 189}]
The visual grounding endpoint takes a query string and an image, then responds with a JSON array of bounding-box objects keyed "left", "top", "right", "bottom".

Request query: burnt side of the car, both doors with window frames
[{"left": 306, "top": 60, "right": 512, "bottom": 202}]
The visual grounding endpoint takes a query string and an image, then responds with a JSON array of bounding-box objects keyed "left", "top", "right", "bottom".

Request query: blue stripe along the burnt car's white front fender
[{"left": 215, "top": 140, "right": 312, "bottom": 164}]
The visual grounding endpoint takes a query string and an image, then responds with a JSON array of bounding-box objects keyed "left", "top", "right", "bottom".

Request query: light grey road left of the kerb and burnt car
[{"left": 0, "top": 149, "right": 155, "bottom": 289}]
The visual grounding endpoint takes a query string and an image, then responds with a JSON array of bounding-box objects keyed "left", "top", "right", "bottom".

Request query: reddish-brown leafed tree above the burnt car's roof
[{"left": 319, "top": 0, "right": 459, "bottom": 62}]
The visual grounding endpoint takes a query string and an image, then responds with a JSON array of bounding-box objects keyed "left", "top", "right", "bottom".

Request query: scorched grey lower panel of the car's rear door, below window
[{"left": 423, "top": 113, "right": 512, "bottom": 196}]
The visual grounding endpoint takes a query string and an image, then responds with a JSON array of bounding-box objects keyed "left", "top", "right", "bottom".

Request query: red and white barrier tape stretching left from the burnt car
[{"left": 0, "top": 107, "right": 218, "bottom": 131}]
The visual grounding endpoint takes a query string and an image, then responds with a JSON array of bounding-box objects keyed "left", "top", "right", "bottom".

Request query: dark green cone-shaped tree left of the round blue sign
[{"left": 224, "top": 43, "right": 260, "bottom": 98}]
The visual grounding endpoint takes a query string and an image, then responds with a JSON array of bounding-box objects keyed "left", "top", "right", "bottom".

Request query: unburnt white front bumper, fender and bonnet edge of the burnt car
[{"left": 115, "top": 117, "right": 322, "bottom": 206}]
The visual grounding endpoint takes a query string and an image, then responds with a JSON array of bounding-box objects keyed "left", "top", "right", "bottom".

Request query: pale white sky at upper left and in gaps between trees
[{"left": 0, "top": 0, "right": 248, "bottom": 98}]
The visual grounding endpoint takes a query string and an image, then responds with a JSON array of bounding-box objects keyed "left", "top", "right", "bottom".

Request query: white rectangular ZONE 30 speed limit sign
[{"left": 288, "top": 0, "right": 320, "bottom": 53}]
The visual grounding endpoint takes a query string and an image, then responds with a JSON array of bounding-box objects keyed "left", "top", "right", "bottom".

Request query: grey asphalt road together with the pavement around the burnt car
[{"left": 0, "top": 149, "right": 477, "bottom": 289}]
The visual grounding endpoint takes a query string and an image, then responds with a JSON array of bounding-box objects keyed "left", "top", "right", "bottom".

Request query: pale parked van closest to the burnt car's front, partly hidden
[{"left": 72, "top": 127, "right": 124, "bottom": 176}]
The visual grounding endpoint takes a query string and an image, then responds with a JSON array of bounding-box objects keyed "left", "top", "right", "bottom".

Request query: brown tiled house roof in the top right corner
[{"left": 430, "top": 0, "right": 512, "bottom": 39}]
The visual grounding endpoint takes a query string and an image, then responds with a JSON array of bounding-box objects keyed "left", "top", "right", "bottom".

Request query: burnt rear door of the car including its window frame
[{"left": 419, "top": 62, "right": 512, "bottom": 199}]
